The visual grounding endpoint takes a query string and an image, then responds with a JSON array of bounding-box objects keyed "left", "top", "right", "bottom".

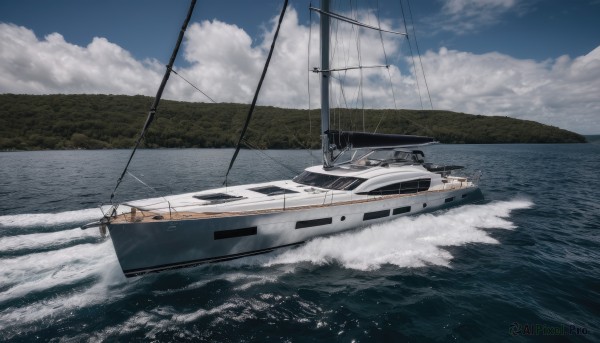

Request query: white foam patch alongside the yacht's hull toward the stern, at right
[{"left": 263, "top": 200, "right": 533, "bottom": 270}]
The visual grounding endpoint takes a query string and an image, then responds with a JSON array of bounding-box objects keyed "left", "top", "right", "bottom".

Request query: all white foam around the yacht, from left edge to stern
[{"left": 0, "top": 200, "right": 533, "bottom": 337}]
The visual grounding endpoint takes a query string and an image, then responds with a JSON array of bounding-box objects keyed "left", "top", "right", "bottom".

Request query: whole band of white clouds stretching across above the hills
[{"left": 0, "top": 4, "right": 600, "bottom": 133}]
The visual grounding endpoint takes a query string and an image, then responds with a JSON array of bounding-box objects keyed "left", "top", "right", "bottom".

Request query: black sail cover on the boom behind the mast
[{"left": 326, "top": 130, "right": 435, "bottom": 150}]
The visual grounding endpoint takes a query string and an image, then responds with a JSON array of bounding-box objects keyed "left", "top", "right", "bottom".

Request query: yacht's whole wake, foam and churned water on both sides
[{"left": 0, "top": 200, "right": 533, "bottom": 338}]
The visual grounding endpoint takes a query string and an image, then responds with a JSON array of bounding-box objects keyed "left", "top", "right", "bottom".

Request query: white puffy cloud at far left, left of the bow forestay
[{"left": 0, "top": 23, "right": 160, "bottom": 94}]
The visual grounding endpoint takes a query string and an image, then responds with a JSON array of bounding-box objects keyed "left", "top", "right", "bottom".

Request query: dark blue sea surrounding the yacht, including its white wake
[{"left": 0, "top": 144, "right": 600, "bottom": 342}]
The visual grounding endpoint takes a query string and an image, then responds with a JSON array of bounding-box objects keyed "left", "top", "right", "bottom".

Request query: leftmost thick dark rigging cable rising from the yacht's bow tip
[{"left": 110, "top": 0, "right": 197, "bottom": 203}]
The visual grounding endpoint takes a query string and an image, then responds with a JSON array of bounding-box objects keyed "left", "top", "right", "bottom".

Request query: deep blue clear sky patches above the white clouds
[{"left": 0, "top": 0, "right": 600, "bottom": 61}]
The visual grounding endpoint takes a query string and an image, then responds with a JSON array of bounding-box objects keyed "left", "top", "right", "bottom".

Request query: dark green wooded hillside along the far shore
[{"left": 0, "top": 94, "right": 586, "bottom": 150}]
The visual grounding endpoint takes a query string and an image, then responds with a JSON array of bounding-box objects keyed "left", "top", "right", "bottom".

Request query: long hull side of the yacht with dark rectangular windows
[{"left": 108, "top": 183, "right": 482, "bottom": 277}]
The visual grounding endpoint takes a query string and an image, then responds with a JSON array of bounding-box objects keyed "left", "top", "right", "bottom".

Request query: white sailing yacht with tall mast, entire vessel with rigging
[{"left": 83, "top": 0, "right": 482, "bottom": 277}]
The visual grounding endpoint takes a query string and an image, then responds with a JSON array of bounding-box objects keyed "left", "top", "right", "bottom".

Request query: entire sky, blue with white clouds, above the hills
[{"left": 0, "top": 0, "right": 600, "bottom": 134}]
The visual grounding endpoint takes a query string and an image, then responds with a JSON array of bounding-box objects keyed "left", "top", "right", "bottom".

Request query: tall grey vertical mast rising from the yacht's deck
[{"left": 320, "top": 0, "right": 333, "bottom": 168}]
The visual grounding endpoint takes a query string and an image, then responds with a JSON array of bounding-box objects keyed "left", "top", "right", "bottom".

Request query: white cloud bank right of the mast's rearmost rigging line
[{"left": 423, "top": 47, "right": 600, "bottom": 133}]
